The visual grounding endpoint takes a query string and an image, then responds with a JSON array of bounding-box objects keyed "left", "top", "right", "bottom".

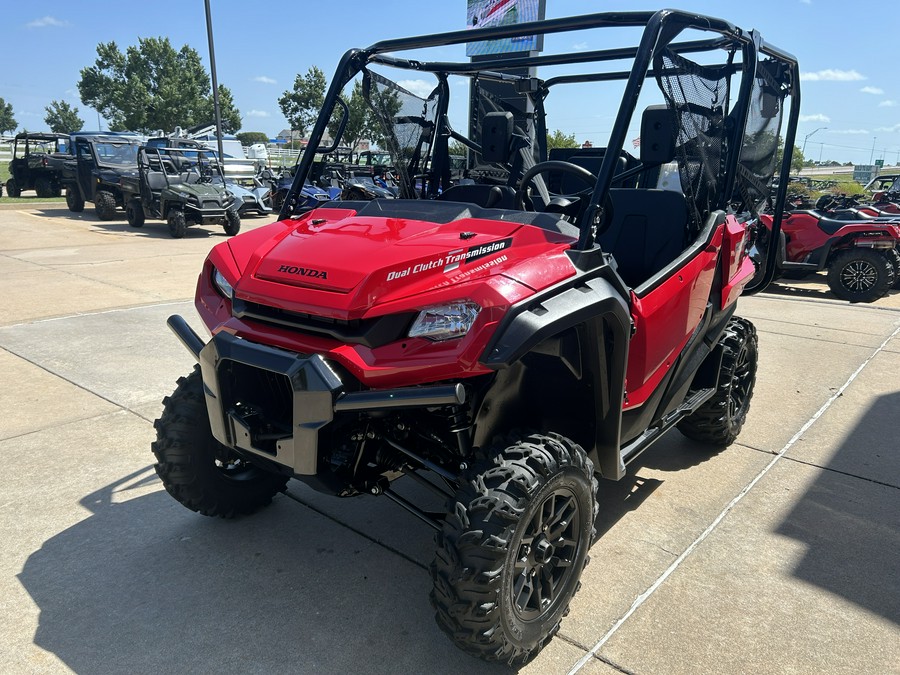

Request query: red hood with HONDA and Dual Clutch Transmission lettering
[{"left": 230, "top": 208, "right": 571, "bottom": 316}]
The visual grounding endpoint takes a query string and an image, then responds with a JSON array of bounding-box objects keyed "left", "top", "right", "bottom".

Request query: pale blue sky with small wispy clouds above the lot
[{"left": 0, "top": 0, "right": 900, "bottom": 164}]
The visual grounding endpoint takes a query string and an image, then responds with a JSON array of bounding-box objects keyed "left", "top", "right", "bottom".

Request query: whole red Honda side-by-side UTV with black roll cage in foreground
[{"left": 153, "top": 10, "right": 799, "bottom": 664}]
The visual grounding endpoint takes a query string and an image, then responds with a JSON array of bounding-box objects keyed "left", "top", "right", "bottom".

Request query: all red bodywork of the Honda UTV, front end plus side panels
[{"left": 196, "top": 209, "right": 753, "bottom": 408}]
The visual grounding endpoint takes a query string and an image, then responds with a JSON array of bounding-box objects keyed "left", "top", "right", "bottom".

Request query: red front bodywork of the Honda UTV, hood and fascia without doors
[{"left": 196, "top": 209, "right": 575, "bottom": 388}]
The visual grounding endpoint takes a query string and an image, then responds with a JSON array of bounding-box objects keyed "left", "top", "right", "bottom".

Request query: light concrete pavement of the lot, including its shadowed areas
[{"left": 0, "top": 205, "right": 900, "bottom": 674}]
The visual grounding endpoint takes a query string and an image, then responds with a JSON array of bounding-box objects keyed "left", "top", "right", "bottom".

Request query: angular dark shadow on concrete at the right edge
[{"left": 776, "top": 392, "right": 900, "bottom": 624}]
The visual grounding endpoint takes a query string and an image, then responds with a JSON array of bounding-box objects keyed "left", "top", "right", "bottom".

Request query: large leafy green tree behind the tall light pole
[{"left": 78, "top": 38, "right": 241, "bottom": 133}]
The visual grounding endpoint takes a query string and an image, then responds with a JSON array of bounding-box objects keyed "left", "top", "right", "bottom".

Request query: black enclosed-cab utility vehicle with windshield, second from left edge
[{"left": 62, "top": 134, "right": 140, "bottom": 220}]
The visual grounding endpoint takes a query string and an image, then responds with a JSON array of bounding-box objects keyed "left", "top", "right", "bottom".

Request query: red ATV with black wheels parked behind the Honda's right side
[{"left": 761, "top": 196, "right": 900, "bottom": 302}]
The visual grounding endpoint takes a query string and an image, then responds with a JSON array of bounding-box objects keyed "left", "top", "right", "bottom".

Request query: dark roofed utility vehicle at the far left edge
[{"left": 6, "top": 132, "right": 68, "bottom": 198}]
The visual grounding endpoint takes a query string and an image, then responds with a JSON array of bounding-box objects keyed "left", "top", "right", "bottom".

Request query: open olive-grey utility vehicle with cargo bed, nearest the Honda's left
[{"left": 121, "top": 146, "right": 241, "bottom": 239}]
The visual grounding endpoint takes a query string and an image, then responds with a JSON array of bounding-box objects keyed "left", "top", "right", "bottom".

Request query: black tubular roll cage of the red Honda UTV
[{"left": 279, "top": 9, "right": 800, "bottom": 290}]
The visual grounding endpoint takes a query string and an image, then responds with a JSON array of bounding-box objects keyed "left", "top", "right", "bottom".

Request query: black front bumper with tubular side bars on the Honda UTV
[{"left": 168, "top": 315, "right": 466, "bottom": 476}]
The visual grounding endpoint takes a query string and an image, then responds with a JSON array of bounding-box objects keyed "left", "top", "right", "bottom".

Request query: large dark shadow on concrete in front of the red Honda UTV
[{"left": 18, "top": 467, "right": 511, "bottom": 674}]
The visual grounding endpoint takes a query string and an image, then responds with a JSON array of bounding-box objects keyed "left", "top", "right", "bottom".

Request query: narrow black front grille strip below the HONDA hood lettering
[{"left": 232, "top": 298, "right": 415, "bottom": 348}]
